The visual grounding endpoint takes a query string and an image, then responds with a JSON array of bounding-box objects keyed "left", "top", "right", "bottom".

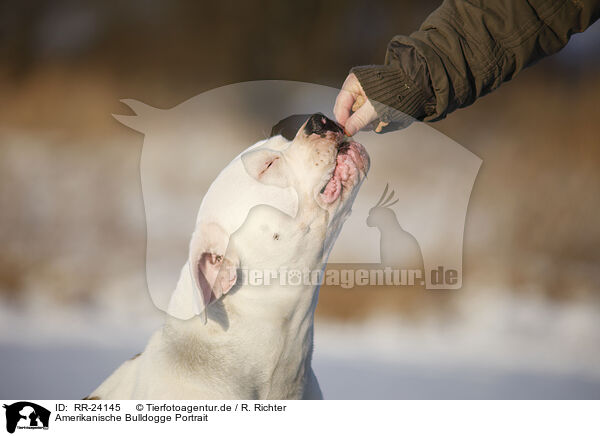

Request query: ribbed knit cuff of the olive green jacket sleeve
[{"left": 350, "top": 65, "right": 432, "bottom": 125}]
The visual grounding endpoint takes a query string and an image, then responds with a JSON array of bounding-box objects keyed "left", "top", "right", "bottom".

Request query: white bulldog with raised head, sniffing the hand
[{"left": 88, "top": 114, "right": 369, "bottom": 399}]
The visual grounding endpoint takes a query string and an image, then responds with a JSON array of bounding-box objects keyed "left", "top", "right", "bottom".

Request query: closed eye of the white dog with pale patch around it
[{"left": 241, "top": 148, "right": 289, "bottom": 188}]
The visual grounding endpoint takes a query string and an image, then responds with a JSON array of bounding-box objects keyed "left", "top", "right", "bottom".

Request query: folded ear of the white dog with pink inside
[{"left": 188, "top": 225, "right": 237, "bottom": 320}]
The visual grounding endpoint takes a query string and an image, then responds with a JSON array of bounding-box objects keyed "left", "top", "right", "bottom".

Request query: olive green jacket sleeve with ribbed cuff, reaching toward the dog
[{"left": 351, "top": 0, "right": 600, "bottom": 128}]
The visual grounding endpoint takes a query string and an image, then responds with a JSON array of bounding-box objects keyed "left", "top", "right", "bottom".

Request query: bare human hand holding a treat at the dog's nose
[{"left": 333, "top": 73, "right": 377, "bottom": 136}]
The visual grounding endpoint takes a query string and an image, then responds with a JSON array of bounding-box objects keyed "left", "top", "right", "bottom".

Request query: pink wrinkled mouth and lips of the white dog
[{"left": 319, "top": 139, "right": 370, "bottom": 204}]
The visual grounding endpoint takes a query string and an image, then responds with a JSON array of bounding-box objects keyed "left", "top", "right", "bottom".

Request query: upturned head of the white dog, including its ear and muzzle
[{"left": 171, "top": 113, "right": 369, "bottom": 320}]
